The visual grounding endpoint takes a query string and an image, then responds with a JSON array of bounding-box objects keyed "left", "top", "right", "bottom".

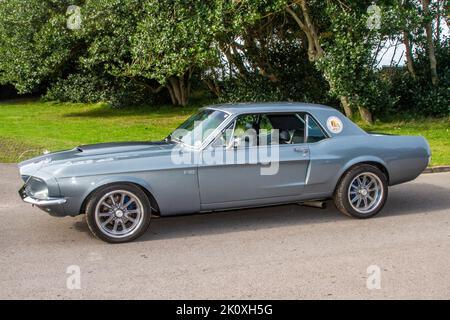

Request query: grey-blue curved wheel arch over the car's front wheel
[{"left": 79, "top": 178, "right": 160, "bottom": 215}]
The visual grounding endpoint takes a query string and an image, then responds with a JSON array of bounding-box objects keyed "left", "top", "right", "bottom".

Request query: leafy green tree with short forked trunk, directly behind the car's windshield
[{"left": 128, "top": 0, "right": 222, "bottom": 106}]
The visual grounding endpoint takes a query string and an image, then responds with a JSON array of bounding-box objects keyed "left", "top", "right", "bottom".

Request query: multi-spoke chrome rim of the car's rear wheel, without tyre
[{"left": 348, "top": 172, "right": 383, "bottom": 214}]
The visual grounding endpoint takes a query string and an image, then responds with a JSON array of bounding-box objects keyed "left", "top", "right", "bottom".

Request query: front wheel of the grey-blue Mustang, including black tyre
[{"left": 86, "top": 183, "right": 152, "bottom": 243}]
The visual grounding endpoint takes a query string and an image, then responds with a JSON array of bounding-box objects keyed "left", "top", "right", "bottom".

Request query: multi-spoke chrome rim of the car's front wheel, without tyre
[{"left": 95, "top": 190, "right": 144, "bottom": 238}]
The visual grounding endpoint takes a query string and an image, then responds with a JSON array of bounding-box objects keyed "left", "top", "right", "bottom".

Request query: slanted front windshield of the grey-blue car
[{"left": 169, "top": 109, "right": 228, "bottom": 146}]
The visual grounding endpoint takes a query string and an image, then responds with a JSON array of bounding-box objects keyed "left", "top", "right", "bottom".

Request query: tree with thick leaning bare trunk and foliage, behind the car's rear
[{"left": 286, "top": 0, "right": 414, "bottom": 123}]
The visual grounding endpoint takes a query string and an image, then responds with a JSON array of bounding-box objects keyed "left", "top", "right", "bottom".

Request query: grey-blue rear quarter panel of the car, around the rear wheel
[{"left": 305, "top": 134, "right": 430, "bottom": 197}]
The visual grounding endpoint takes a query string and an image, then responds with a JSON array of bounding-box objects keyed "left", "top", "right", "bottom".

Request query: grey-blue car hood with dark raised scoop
[{"left": 18, "top": 141, "right": 177, "bottom": 180}]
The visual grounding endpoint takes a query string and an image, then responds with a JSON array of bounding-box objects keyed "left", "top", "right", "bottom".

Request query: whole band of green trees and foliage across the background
[{"left": 0, "top": 0, "right": 450, "bottom": 120}]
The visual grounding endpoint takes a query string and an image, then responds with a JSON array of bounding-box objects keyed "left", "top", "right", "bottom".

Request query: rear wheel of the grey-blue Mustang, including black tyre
[{"left": 334, "top": 164, "right": 388, "bottom": 219}]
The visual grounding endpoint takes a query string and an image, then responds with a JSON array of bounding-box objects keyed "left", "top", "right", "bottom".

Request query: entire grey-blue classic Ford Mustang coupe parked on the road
[{"left": 19, "top": 103, "right": 431, "bottom": 243}]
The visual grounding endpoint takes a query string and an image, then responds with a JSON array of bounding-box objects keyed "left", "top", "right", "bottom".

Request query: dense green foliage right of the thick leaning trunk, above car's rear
[{"left": 317, "top": 1, "right": 408, "bottom": 115}]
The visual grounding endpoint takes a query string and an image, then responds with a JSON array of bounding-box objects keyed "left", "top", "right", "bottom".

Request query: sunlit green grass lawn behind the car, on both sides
[{"left": 0, "top": 100, "right": 450, "bottom": 165}]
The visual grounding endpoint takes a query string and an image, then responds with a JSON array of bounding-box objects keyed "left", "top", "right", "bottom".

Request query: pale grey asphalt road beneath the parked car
[{"left": 0, "top": 165, "right": 450, "bottom": 299}]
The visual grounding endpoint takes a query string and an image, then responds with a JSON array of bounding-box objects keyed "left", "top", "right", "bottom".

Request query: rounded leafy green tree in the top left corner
[{"left": 0, "top": 0, "right": 82, "bottom": 93}]
